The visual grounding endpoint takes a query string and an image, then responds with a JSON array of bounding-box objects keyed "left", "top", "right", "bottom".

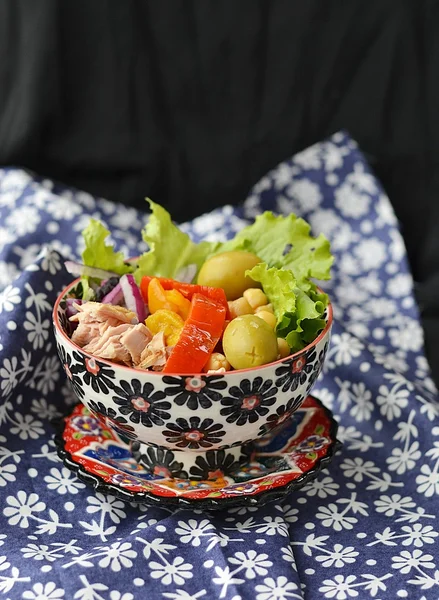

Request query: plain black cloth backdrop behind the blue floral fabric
[{"left": 0, "top": 0, "right": 439, "bottom": 378}]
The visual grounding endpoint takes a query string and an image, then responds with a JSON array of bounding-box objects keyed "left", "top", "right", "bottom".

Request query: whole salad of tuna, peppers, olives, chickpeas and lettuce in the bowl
[{"left": 66, "top": 200, "right": 333, "bottom": 373}]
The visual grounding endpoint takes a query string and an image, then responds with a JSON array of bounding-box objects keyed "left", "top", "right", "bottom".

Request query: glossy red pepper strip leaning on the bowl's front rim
[{"left": 163, "top": 293, "right": 226, "bottom": 373}]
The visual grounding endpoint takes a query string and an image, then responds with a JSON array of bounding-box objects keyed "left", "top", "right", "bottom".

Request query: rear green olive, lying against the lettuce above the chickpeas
[{"left": 197, "top": 250, "right": 261, "bottom": 300}]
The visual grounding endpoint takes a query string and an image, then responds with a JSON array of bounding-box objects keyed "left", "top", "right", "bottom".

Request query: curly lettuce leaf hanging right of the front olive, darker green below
[{"left": 247, "top": 263, "right": 328, "bottom": 352}]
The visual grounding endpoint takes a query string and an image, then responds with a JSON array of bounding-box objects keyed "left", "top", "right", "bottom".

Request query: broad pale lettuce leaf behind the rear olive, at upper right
[{"left": 219, "top": 211, "right": 334, "bottom": 290}]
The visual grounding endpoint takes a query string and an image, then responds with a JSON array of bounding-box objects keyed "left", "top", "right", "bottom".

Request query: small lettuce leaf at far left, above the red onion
[{"left": 82, "top": 219, "right": 132, "bottom": 275}]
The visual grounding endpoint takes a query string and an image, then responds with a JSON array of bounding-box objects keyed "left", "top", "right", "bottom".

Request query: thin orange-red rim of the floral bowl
[{"left": 52, "top": 277, "right": 333, "bottom": 379}]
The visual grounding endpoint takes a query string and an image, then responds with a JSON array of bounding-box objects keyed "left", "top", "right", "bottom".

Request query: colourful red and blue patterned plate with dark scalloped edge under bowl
[{"left": 55, "top": 396, "right": 341, "bottom": 510}]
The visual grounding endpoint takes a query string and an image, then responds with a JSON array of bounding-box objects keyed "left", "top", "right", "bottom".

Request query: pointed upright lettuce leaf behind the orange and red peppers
[{"left": 134, "top": 199, "right": 220, "bottom": 283}]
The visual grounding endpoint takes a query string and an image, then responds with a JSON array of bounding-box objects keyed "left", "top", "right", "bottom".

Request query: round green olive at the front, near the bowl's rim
[{"left": 223, "top": 315, "right": 279, "bottom": 369}]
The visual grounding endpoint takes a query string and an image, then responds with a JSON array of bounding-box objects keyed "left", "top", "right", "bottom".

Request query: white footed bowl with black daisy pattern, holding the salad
[{"left": 53, "top": 280, "right": 332, "bottom": 480}]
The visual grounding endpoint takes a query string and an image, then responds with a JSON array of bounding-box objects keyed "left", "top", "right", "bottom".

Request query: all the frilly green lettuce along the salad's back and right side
[{"left": 82, "top": 200, "right": 333, "bottom": 351}]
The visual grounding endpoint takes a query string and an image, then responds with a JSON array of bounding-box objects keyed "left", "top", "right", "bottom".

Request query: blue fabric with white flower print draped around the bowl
[{"left": 0, "top": 133, "right": 439, "bottom": 600}]
